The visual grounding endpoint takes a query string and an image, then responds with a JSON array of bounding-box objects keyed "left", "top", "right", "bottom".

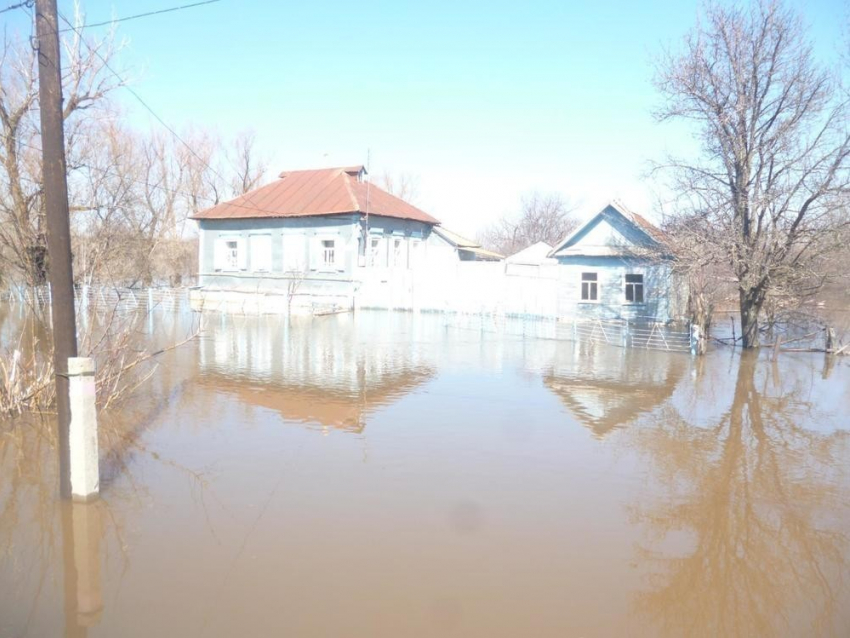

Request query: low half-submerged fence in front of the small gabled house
[{"left": 446, "top": 313, "right": 697, "bottom": 354}]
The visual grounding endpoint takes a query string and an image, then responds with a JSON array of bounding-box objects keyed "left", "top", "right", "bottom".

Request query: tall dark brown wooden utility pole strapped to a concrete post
[{"left": 36, "top": 0, "right": 77, "bottom": 498}]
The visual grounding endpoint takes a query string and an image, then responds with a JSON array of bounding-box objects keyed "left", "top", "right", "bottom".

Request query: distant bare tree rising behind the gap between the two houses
[{"left": 479, "top": 192, "right": 578, "bottom": 255}]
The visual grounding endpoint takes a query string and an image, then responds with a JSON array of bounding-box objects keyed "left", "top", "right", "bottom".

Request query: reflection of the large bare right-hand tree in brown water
[{"left": 633, "top": 357, "right": 850, "bottom": 636}]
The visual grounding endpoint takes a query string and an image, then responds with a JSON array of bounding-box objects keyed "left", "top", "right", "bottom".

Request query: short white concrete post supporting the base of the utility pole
[{"left": 68, "top": 357, "right": 100, "bottom": 501}]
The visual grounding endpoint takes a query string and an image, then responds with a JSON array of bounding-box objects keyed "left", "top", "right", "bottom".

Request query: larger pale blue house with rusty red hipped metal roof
[{"left": 193, "top": 166, "right": 501, "bottom": 305}]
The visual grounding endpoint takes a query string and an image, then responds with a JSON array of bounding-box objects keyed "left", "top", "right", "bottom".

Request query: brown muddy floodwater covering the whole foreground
[{"left": 0, "top": 312, "right": 850, "bottom": 638}]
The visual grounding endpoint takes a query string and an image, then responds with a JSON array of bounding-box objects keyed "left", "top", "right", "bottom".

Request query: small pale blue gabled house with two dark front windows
[{"left": 549, "top": 202, "right": 681, "bottom": 323}]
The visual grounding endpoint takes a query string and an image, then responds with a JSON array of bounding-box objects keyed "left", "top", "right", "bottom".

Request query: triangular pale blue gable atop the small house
[{"left": 550, "top": 204, "right": 661, "bottom": 258}]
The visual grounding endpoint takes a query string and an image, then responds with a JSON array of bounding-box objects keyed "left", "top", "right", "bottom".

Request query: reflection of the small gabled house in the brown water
[{"left": 543, "top": 343, "right": 688, "bottom": 438}]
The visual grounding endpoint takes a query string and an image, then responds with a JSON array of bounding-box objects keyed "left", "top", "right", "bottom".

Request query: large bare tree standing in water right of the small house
[{"left": 656, "top": 1, "right": 850, "bottom": 347}]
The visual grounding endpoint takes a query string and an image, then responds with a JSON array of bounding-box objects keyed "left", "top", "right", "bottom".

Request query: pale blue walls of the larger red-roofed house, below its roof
[{"left": 198, "top": 214, "right": 457, "bottom": 311}]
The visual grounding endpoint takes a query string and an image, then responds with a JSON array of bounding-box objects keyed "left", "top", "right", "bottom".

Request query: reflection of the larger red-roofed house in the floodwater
[{"left": 200, "top": 315, "right": 434, "bottom": 432}]
